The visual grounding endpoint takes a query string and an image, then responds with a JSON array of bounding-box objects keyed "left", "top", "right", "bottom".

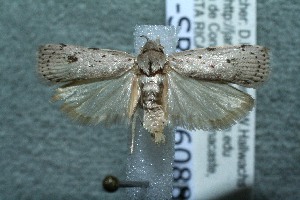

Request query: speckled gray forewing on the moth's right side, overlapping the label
[{"left": 168, "top": 45, "right": 269, "bottom": 88}]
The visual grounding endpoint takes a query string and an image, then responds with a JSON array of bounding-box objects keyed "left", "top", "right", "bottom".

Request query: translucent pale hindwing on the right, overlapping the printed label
[{"left": 167, "top": 71, "right": 254, "bottom": 130}]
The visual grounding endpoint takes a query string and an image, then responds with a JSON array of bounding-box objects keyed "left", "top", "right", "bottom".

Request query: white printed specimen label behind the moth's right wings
[{"left": 166, "top": 0, "right": 256, "bottom": 200}]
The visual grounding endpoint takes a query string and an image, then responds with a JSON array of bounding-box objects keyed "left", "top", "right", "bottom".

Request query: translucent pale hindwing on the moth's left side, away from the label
[{"left": 53, "top": 71, "right": 139, "bottom": 125}]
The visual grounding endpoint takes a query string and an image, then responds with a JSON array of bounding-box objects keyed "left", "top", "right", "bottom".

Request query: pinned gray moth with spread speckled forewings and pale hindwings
[{"left": 38, "top": 36, "right": 270, "bottom": 143}]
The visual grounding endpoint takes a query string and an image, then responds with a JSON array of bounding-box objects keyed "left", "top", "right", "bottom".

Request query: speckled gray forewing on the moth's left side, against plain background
[{"left": 38, "top": 44, "right": 134, "bottom": 82}]
